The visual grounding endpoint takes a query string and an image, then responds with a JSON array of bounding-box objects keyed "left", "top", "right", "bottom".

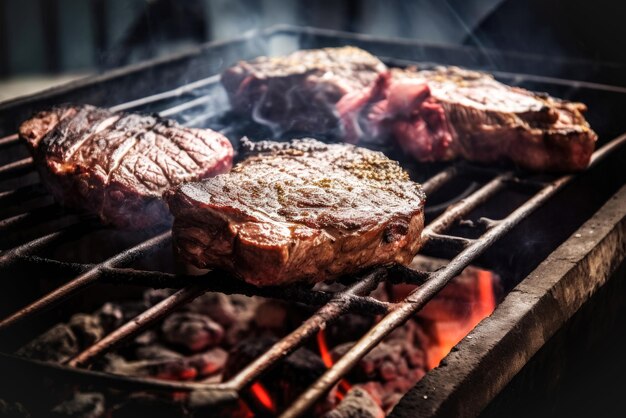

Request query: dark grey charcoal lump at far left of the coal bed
[{"left": 17, "top": 324, "right": 80, "bottom": 363}]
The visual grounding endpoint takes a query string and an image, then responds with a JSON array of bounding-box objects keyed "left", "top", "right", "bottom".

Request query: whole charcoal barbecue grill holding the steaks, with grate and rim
[{"left": 0, "top": 26, "right": 626, "bottom": 417}]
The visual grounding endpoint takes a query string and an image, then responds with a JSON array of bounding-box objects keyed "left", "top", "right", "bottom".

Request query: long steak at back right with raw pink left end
[{"left": 337, "top": 67, "right": 597, "bottom": 171}]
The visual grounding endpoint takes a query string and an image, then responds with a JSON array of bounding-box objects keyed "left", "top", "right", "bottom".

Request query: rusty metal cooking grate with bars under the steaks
[{"left": 0, "top": 25, "right": 626, "bottom": 418}]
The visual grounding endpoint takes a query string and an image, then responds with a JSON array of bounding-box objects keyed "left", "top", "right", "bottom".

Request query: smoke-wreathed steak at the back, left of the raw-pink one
[{"left": 221, "top": 47, "right": 386, "bottom": 133}]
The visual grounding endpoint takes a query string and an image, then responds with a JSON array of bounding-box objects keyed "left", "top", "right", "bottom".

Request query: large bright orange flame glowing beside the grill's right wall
[{"left": 427, "top": 270, "right": 496, "bottom": 369}]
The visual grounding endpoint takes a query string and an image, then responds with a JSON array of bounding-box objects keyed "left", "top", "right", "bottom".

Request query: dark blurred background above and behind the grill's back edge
[{"left": 0, "top": 0, "right": 626, "bottom": 100}]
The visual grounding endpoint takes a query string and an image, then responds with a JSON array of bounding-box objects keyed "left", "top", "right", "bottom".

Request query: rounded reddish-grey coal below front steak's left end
[{"left": 161, "top": 312, "right": 224, "bottom": 352}]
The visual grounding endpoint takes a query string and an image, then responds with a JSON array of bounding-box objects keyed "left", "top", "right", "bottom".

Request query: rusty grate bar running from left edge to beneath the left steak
[{"left": 0, "top": 231, "right": 171, "bottom": 331}]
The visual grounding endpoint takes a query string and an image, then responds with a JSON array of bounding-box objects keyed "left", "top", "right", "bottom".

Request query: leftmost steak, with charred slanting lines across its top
[{"left": 19, "top": 105, "right": 233, "bottom": 229}]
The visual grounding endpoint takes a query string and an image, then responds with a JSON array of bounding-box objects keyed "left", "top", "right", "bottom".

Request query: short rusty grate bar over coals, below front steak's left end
[{"left": 67, "top": 283, "right": 207, "bottom": 367}]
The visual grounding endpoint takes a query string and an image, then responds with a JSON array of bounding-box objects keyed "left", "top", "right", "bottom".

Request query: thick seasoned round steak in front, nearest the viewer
[{"left": 164, "top": 139, "right": 425, "bottom": 286}]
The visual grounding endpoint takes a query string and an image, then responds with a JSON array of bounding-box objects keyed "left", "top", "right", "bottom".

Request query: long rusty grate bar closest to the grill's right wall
[{"left": 280, "top": 135, "right": 626, "bottom": 418}]
